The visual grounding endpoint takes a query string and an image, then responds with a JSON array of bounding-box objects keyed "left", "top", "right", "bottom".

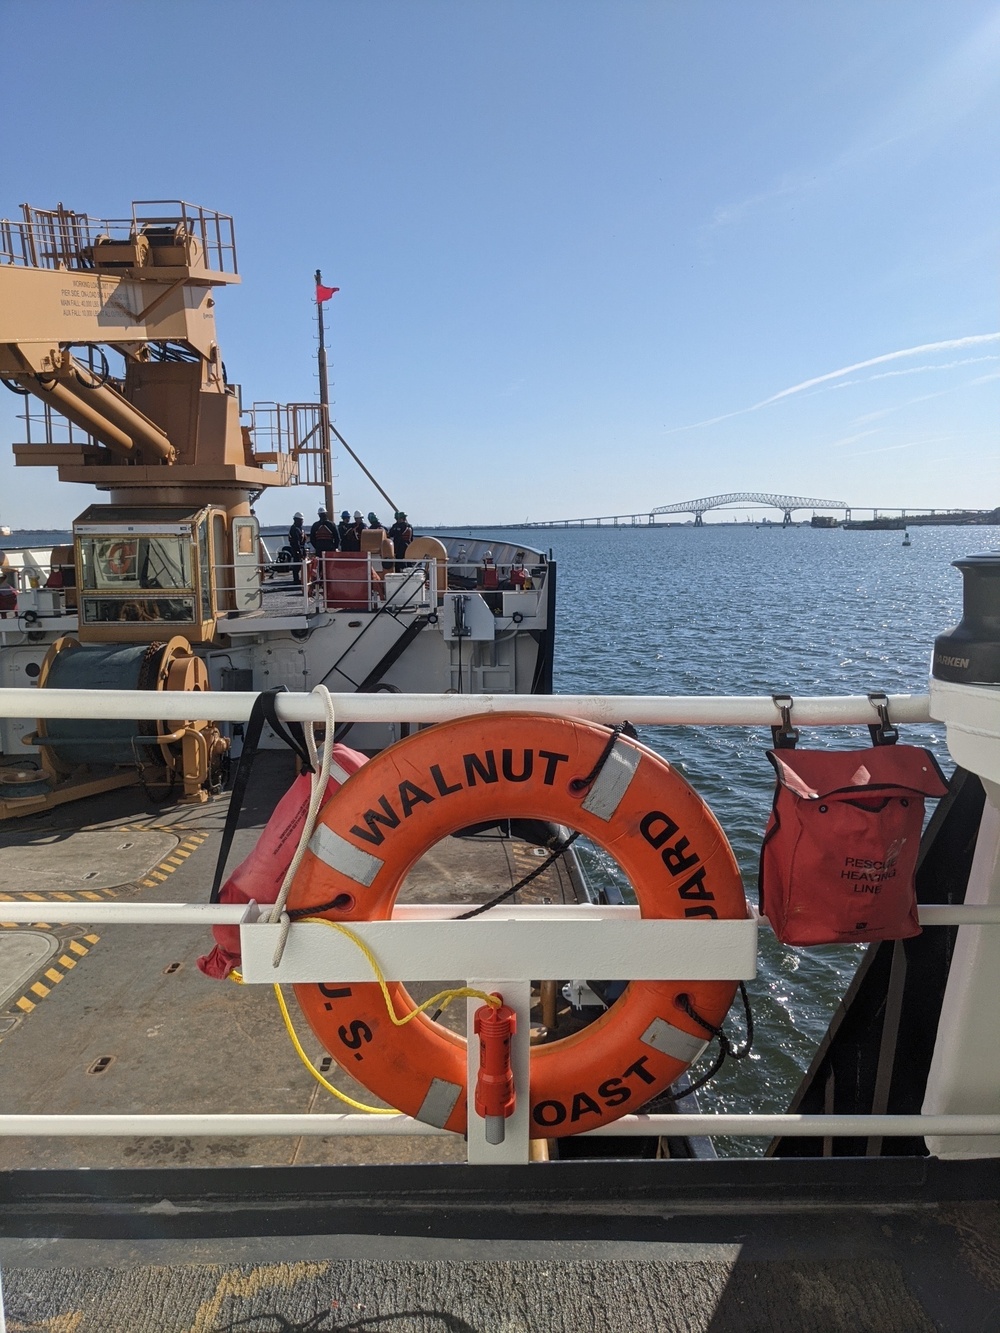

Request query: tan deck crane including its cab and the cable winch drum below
[{"left": 0, "top": 201, "right": 329, "bottom": 799}]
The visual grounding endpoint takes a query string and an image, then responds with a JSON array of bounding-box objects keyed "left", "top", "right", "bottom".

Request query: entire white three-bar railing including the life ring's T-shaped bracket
[{"left": 0, "top": 688, "right": 1000, "bottom": 1162}]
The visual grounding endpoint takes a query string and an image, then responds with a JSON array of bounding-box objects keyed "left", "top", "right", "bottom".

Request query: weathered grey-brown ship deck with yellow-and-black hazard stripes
[{"left": 0, "top": 752, "right": 1000, "bottom": 1333}]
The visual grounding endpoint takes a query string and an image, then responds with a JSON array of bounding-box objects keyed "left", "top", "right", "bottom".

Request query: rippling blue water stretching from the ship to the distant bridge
[{"left": 490, "top": 524, "right": 1000, "bottom": 1135}]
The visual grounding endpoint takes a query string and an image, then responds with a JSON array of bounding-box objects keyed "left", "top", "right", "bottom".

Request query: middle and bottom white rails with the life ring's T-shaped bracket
[{"left": 0, "top": 901, "right": 1000, "bottom": 1164}]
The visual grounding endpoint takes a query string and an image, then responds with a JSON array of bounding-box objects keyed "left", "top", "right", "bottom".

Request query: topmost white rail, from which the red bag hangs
[{"left": 0, "top": 688, "right": 932, "bottom": 726}]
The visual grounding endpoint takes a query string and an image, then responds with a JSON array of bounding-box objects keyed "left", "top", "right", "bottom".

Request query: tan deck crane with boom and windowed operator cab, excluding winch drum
[{"left": 0, "top": 201, "right": 321, "bottom": 643}]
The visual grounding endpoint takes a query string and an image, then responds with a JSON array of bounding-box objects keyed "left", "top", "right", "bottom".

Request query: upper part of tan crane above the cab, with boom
[{"left": 0, "top": 200, "right": 297, "bottom": 503}]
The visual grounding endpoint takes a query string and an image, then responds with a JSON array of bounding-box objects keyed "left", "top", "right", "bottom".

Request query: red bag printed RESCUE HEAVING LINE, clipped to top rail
[{"left": 759, "top": 745, "right": 948, "bottom": 945}]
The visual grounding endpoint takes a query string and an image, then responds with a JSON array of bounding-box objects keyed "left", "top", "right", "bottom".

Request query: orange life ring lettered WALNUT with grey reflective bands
[{"left": 288, "top": 713, "right": 747, "bottom": 1138}]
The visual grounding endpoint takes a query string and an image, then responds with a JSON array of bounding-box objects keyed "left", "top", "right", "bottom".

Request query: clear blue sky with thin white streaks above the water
[{"left": 0, "top": 0, "right": 1000, "bottom": 527}]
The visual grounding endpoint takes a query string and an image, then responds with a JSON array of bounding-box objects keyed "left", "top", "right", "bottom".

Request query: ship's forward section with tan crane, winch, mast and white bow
[{"left": 0, "top": 200, "right": 555, "bottom": 818}]
